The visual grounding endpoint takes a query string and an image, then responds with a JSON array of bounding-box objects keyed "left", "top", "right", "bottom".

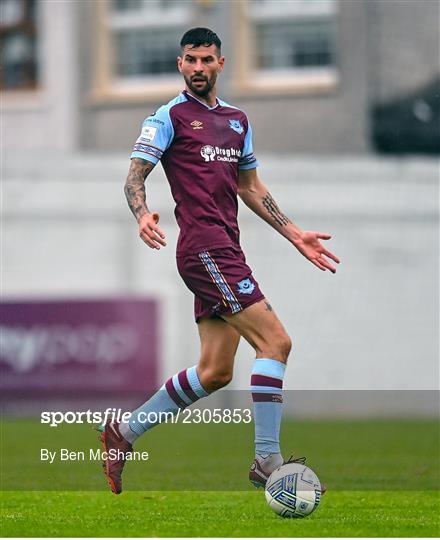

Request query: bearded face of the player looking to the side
[{"left": 177, "top": 45, "right": 225, "bottom": 97}]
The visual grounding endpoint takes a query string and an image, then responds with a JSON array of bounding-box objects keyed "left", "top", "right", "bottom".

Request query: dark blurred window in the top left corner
[{"left": 0, "top": 0, "right": 38, "bottom": 90}]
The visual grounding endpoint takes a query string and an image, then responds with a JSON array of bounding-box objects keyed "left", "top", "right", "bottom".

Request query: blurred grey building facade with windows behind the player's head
[{"left": 0, "top": 0, "right": 439, "bottom": 155}]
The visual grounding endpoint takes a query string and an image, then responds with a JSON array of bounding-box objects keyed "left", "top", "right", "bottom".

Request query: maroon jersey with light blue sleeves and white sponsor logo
[{"left": 131, "top": 91, "right": 258, "bottom": 257}]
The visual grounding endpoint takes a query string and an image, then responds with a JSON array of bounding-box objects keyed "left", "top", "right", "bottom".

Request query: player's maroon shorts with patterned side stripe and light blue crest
[{"left": 177, "top": 247, "right": 264, "bottom": 322}]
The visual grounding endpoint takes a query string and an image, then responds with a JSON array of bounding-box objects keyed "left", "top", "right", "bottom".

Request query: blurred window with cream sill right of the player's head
[{"left": 232, "top": 0, "right": 338, "bottom": 93}]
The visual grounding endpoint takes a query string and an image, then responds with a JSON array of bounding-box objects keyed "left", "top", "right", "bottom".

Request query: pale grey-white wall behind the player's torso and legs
[{"left": 3, "top": 155, "right": 439, "bottom": 402}]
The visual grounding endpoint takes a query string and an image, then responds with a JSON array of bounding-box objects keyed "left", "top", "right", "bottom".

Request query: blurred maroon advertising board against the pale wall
[{"left": 0, "top": 299, "right": 159, "bottom": 397}]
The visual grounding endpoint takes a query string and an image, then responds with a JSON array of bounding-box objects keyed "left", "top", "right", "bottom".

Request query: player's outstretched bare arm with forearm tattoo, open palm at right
[{"left": 238, "top": 169, "right": 339, "bottom": 273}]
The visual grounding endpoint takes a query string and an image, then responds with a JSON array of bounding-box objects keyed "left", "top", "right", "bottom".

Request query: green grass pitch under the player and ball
[{"left": 1, "top": 420, "right": 440, "bottom": 537}]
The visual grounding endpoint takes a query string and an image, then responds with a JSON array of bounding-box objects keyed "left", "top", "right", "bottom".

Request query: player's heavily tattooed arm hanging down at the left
[{"left": 124, "top": 158, "right": 166, "bottom": 249}]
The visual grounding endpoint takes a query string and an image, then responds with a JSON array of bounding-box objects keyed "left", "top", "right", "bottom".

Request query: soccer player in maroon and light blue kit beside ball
[{"left": 101, "top": 28, "right": 339, "bottom": 493}]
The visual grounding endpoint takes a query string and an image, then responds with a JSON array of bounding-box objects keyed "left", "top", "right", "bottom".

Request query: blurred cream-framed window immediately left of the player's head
[{"left": 91, "top": 0, "right": 193, "bottom": 102}]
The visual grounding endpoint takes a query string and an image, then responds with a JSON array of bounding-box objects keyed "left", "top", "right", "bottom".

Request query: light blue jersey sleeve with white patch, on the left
[{"left": 130, "top": 105, "right": 174, "bottom": 164}]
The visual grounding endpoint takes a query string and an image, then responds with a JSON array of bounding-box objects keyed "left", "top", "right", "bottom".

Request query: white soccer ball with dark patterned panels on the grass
[{"left": 265, "top": 463, "right": 322, "bottom": 518}]
